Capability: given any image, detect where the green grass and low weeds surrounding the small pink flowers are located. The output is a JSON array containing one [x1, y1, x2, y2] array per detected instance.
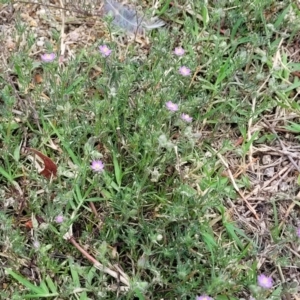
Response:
[[0, 0, 300, 300]]
